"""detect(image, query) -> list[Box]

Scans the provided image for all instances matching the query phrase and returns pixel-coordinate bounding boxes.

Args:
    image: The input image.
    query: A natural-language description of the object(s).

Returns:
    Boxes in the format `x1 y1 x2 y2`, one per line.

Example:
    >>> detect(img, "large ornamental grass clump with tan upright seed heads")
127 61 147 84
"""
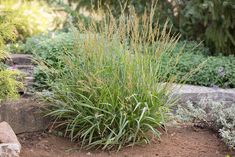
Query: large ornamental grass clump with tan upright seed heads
47 5 185 150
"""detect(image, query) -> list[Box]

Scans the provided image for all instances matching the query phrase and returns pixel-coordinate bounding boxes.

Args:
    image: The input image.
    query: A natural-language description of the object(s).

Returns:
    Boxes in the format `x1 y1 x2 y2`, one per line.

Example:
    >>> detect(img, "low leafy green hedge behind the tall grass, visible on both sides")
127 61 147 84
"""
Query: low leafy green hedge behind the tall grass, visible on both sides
26 33 235 88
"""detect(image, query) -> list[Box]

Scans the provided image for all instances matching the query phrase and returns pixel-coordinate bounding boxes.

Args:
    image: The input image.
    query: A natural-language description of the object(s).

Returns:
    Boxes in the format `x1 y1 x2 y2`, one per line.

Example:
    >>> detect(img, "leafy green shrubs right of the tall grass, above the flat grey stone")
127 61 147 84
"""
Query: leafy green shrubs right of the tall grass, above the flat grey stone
164 42 235 88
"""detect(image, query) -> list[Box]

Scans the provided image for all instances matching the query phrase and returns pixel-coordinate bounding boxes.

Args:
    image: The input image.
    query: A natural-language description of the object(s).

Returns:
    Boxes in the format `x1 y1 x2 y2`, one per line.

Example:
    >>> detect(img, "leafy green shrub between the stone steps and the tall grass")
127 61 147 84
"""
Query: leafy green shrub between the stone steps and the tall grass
24 32 74 89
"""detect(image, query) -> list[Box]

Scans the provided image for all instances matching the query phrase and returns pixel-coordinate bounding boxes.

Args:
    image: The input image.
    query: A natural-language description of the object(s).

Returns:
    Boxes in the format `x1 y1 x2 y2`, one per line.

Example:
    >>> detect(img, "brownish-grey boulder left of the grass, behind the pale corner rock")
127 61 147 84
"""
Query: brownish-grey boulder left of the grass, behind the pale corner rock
0 98 49 134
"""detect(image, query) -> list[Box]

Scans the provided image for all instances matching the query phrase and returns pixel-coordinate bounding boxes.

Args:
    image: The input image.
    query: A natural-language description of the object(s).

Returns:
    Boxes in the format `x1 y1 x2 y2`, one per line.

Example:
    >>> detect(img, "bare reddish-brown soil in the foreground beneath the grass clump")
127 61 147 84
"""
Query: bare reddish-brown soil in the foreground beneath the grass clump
18 126 235 157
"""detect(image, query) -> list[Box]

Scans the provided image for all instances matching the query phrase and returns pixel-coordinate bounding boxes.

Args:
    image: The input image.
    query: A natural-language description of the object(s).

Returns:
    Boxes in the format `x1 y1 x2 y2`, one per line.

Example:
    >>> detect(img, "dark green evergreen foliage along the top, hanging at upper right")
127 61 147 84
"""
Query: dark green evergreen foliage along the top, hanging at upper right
62 0 235 55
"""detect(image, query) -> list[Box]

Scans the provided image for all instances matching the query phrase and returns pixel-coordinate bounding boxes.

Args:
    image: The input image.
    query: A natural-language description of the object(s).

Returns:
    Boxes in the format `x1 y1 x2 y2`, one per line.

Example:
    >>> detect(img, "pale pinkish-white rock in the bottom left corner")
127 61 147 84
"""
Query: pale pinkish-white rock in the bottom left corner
0 122 21 157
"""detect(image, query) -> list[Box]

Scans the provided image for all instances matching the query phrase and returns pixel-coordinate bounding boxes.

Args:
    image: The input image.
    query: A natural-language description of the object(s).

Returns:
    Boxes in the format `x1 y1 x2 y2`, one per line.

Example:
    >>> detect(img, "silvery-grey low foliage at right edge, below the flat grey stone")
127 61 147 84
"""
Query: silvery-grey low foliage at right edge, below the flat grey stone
177 100 235 149
